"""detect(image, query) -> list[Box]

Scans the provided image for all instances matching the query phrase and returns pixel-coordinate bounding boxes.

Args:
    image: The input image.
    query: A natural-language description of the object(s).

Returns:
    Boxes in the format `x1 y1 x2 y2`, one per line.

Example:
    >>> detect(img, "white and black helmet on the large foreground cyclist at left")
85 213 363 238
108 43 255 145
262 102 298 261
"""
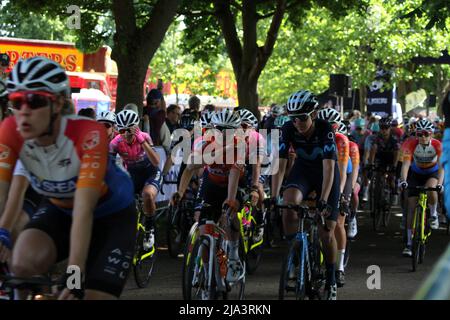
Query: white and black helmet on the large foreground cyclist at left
7 57 70 97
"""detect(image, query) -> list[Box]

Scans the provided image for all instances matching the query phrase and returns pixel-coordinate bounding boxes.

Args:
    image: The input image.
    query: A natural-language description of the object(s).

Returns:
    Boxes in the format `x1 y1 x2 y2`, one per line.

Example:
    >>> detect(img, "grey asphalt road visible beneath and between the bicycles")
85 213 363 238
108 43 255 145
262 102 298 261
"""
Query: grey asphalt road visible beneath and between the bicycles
121 207 450 300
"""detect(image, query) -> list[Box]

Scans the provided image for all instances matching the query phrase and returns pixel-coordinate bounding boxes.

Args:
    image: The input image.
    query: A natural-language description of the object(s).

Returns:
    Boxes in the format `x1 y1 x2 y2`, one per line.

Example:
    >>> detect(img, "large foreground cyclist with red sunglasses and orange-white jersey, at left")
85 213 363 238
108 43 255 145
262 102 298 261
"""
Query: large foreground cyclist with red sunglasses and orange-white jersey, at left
0 57 136 299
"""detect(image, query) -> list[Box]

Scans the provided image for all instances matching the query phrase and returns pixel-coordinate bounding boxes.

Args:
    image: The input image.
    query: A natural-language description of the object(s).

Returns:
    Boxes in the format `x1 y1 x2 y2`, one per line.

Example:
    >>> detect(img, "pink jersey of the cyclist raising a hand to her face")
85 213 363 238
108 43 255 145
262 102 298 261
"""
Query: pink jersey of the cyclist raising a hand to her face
109 132 153 166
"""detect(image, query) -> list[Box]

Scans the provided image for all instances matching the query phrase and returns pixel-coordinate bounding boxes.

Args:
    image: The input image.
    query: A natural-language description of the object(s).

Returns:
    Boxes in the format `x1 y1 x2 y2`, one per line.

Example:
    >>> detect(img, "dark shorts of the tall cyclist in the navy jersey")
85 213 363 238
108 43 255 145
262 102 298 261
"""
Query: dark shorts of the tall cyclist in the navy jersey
284 162 340 221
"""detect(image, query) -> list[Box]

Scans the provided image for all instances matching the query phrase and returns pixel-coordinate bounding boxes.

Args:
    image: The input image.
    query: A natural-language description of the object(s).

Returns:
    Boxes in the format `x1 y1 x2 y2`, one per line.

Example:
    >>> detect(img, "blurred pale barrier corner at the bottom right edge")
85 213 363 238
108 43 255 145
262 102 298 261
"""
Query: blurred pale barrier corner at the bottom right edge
413 244 450 300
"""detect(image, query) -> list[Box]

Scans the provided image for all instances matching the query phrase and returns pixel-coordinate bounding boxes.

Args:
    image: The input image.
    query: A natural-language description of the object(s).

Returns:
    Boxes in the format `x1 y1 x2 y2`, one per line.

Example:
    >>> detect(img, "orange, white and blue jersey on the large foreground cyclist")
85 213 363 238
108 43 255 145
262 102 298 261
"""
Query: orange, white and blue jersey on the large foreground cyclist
0 116 133 217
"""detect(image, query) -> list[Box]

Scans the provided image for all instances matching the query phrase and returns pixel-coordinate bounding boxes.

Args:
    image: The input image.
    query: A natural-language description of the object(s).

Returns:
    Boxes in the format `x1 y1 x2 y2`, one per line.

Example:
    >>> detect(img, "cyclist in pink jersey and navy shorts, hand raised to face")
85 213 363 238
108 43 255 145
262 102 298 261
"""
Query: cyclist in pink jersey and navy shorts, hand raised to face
109 110 162 250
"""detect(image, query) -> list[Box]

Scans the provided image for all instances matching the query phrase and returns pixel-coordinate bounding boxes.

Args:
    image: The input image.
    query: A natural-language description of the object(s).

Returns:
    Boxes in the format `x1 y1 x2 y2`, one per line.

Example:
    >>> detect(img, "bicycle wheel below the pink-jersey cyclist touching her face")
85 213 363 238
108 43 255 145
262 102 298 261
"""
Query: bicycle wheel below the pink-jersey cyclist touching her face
133 228 156 288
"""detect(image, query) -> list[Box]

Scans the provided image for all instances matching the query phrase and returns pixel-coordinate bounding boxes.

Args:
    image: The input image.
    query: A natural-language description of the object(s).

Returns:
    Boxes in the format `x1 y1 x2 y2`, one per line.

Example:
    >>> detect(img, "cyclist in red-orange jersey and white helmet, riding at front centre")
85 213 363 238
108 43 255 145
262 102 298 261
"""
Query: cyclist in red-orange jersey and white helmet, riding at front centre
172 109 245 282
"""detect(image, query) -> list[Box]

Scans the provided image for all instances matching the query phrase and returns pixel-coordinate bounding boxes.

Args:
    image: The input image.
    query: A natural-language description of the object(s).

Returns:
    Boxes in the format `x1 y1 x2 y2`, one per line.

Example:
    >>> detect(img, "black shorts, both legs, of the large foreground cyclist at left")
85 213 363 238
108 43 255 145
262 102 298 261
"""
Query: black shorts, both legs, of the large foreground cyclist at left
25 199 137 298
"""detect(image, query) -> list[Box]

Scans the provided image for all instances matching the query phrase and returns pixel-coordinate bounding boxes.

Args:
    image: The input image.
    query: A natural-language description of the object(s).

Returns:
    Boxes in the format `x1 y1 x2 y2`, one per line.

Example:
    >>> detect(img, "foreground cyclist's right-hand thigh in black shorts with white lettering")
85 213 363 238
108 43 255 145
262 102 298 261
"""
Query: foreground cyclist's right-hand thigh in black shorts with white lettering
85 203 137 300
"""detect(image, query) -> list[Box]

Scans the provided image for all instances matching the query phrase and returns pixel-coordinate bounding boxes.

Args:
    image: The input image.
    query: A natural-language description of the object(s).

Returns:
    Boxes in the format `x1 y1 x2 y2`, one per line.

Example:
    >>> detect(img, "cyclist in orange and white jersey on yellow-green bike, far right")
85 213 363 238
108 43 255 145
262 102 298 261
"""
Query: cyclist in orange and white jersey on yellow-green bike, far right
399 119 444 257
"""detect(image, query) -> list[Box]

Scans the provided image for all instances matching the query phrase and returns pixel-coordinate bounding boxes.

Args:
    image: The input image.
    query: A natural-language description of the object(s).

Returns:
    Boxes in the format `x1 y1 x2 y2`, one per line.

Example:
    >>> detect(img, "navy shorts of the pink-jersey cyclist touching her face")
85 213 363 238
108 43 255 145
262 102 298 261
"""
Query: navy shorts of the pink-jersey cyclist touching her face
128 159 162 193
